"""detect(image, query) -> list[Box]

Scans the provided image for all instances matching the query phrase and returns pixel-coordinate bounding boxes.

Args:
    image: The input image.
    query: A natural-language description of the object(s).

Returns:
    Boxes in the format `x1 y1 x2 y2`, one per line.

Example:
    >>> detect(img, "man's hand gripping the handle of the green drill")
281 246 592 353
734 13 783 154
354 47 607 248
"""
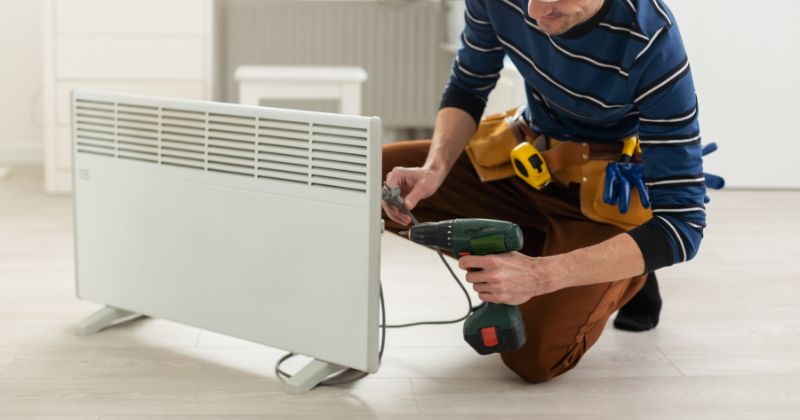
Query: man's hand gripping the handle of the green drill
458 252 567 305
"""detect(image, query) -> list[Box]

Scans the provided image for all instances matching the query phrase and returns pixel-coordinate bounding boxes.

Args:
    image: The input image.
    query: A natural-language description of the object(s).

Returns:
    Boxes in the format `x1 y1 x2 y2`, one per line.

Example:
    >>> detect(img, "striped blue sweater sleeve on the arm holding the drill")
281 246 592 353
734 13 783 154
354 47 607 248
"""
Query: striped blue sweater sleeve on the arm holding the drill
629 19 706 272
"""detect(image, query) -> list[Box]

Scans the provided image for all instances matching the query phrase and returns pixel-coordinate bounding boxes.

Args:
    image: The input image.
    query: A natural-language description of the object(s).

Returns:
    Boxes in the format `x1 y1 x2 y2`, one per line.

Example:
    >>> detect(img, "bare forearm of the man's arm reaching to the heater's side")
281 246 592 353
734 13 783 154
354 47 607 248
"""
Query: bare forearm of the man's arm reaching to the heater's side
423 108 477 176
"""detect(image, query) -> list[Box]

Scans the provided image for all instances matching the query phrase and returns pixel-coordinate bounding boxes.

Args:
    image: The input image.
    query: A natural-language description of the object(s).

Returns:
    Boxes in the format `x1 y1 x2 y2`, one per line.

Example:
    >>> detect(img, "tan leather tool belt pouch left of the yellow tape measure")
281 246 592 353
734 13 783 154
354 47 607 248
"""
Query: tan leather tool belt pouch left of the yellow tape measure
466 108 533 182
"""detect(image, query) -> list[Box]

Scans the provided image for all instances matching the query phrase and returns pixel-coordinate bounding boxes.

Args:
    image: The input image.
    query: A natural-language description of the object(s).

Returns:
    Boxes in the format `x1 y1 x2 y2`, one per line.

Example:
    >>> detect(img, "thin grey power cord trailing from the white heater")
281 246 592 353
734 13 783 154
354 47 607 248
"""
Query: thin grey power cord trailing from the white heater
275 185 486 386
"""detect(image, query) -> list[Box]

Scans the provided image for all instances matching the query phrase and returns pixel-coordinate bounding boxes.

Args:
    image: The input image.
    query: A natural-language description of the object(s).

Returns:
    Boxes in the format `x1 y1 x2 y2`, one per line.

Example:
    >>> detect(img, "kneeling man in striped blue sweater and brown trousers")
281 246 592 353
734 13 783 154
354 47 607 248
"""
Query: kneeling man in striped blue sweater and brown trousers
384 0 705 382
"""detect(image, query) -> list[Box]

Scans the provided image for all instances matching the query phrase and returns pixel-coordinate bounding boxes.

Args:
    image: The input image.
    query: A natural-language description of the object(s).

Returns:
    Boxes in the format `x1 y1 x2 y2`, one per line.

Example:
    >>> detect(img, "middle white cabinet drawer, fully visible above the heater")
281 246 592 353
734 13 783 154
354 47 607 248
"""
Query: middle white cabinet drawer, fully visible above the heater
55 37 206 80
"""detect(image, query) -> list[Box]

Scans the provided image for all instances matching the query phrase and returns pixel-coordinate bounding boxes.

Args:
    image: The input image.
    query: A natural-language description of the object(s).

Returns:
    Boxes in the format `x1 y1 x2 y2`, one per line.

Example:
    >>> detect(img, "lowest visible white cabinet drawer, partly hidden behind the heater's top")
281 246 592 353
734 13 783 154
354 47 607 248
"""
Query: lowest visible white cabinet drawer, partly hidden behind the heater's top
56 82 208 125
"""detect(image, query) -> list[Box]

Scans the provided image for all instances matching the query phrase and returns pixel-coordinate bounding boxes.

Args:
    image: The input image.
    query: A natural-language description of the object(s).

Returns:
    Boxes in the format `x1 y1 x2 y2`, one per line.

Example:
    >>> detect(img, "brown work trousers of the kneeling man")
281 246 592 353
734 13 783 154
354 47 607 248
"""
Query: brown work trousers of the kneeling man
382 140 645 382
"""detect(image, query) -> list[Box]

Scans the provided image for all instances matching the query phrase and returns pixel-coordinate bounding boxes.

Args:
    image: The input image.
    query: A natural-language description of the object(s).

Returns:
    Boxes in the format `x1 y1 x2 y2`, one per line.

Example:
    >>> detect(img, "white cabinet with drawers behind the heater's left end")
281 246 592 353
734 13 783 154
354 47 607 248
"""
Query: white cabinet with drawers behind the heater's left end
43 0 214 192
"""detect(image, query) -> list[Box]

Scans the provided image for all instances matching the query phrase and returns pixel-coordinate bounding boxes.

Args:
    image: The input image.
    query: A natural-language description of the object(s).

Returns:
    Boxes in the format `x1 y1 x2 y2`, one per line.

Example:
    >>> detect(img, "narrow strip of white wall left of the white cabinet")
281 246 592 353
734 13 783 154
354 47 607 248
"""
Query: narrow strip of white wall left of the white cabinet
0 0 42 162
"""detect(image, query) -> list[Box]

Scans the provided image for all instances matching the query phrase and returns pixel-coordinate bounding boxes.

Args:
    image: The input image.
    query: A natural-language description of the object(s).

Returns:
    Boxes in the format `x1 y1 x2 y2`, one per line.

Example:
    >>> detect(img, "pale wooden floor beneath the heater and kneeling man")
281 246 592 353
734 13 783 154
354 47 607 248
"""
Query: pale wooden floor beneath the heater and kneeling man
0 167 800 420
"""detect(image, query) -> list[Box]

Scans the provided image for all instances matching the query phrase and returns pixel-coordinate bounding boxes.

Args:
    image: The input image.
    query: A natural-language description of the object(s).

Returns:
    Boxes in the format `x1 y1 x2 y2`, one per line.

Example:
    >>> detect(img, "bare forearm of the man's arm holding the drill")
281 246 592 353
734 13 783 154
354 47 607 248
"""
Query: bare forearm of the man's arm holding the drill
542 233 644 289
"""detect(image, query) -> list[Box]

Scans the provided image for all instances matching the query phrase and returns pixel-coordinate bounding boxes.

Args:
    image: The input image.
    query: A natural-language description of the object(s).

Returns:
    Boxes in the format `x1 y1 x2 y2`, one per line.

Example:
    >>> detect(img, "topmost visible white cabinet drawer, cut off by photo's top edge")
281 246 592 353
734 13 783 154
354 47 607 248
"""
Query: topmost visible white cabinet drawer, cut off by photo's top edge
54 0 210 35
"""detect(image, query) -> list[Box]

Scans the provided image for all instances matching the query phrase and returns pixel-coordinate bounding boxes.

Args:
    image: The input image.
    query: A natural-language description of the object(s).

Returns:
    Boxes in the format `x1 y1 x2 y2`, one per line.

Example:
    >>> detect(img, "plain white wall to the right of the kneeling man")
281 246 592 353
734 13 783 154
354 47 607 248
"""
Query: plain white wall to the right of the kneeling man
665 0 800 188
